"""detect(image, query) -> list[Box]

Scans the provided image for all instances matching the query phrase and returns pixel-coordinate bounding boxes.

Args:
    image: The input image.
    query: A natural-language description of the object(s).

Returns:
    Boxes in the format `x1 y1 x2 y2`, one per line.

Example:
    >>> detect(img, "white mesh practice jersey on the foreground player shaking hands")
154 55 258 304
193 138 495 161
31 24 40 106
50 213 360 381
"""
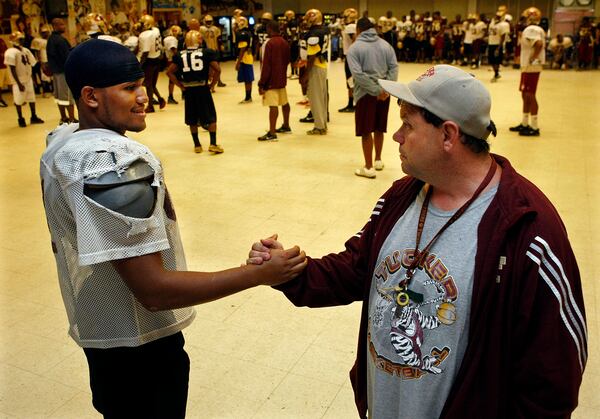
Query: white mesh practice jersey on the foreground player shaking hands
40 124 195 348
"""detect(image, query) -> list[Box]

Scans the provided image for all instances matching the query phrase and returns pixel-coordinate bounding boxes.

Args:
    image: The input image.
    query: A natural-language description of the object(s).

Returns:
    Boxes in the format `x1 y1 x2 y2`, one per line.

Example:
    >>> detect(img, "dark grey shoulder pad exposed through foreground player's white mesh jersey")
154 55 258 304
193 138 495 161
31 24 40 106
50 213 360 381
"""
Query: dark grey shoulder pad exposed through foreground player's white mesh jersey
84 161 156 218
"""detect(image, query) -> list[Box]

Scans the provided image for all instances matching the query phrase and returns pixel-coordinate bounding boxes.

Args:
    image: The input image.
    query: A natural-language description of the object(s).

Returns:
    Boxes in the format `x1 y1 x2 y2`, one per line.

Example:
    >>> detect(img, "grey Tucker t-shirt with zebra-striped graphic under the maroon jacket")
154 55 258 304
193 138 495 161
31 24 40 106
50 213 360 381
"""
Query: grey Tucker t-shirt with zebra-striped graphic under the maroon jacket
367 186 497 419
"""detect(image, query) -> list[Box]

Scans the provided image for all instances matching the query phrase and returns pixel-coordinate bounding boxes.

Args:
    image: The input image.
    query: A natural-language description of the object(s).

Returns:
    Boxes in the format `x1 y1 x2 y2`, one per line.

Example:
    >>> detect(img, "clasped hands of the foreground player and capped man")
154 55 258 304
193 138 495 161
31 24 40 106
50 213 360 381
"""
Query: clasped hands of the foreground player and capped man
246 234 307 286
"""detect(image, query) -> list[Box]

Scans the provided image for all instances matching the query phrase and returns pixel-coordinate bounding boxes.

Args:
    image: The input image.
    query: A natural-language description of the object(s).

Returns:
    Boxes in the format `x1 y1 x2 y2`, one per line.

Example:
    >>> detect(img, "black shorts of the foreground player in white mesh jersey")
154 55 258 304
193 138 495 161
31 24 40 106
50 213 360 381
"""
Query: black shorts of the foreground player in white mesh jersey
83 332 190 419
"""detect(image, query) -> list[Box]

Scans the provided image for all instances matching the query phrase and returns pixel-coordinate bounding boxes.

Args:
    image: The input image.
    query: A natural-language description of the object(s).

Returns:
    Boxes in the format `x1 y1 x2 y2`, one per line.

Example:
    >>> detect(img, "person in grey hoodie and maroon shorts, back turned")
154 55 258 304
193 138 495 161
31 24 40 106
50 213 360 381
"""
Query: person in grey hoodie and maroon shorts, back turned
346 17 398 179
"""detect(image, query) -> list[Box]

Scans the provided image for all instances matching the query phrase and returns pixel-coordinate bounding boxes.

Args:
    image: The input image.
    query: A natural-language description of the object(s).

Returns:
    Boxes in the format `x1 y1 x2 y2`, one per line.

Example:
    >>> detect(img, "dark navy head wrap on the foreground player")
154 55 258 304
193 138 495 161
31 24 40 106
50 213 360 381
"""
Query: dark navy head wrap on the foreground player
65 39 144 99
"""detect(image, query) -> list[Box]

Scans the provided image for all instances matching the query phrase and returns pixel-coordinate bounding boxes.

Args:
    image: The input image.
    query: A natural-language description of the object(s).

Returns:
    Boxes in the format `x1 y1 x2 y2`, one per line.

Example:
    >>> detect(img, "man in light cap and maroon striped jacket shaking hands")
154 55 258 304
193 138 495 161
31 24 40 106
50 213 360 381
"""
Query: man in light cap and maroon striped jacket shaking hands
248 65 587 419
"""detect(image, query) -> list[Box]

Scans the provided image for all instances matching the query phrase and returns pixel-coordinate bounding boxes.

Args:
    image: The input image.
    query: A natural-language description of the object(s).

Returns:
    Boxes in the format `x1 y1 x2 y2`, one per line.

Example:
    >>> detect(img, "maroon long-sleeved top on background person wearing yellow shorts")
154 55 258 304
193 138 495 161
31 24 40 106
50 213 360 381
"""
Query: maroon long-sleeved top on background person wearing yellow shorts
258 35 290 90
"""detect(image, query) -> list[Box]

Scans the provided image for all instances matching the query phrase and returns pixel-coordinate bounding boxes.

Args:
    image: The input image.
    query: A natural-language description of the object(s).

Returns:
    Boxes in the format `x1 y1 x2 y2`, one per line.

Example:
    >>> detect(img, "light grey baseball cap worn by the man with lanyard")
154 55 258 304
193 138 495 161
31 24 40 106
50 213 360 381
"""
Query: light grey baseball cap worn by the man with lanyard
379 64 496 140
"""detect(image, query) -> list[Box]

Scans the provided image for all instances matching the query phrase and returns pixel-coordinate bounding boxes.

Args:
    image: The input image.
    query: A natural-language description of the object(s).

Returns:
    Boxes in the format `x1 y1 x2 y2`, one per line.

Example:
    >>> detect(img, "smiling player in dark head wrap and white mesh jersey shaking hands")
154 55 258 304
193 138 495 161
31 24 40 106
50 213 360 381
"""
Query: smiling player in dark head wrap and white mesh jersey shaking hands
40 39 305 419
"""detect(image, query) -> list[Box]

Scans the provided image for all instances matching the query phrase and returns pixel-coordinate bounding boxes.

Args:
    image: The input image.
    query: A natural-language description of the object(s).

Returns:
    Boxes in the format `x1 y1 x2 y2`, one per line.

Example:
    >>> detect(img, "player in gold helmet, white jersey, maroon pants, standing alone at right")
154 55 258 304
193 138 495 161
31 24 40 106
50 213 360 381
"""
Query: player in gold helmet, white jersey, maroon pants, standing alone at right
510 7 546 137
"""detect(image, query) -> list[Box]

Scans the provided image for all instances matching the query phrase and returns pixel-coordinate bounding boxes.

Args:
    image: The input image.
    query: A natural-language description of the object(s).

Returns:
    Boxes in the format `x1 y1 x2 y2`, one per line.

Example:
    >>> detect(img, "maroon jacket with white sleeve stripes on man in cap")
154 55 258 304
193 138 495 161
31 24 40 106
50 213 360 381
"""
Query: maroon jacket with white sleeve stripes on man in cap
276 155 587 419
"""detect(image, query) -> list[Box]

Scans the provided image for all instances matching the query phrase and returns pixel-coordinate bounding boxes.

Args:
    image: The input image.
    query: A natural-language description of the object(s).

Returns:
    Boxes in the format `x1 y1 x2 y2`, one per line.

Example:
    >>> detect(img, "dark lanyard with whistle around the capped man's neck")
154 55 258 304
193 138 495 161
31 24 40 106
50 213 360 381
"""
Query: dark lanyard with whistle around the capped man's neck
395 158 498 306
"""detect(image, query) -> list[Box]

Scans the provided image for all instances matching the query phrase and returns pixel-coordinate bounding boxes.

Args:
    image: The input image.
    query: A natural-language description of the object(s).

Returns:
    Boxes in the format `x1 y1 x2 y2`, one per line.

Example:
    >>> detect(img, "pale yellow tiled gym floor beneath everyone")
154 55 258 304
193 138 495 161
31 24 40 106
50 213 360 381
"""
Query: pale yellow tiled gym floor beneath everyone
0 62 600 419
